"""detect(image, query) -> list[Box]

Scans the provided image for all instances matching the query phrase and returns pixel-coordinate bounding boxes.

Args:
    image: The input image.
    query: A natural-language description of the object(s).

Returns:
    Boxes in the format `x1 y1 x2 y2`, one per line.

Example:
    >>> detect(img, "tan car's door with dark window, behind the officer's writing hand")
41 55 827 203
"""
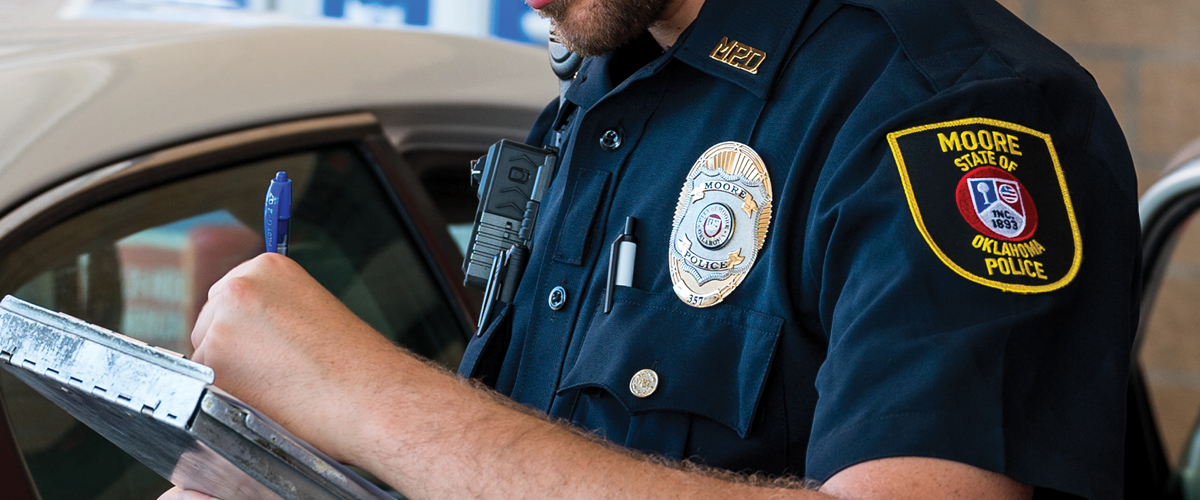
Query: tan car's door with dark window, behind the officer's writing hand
0 113 473 500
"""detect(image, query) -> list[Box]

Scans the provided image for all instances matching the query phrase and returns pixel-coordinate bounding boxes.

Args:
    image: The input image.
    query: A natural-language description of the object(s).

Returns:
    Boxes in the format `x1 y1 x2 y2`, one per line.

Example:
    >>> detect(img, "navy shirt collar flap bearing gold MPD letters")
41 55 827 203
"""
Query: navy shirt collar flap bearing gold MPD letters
674 0 814 98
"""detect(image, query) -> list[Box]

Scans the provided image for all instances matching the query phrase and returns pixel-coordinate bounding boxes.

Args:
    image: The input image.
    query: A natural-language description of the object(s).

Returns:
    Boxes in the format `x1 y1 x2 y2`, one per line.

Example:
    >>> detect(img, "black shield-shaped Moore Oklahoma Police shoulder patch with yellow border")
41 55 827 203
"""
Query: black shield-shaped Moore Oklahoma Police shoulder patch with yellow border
888 119 1084 294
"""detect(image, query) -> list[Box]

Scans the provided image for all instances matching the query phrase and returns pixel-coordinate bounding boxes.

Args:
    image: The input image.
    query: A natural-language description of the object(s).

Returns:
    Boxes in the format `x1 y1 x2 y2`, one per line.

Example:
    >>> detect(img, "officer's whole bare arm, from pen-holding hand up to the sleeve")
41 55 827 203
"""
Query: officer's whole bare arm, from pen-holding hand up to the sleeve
184 254 1028 500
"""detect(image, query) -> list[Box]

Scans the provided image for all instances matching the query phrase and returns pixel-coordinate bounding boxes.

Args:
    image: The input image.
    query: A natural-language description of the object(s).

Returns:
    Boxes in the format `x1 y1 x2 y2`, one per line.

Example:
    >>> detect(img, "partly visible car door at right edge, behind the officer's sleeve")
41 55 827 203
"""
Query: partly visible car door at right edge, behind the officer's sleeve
1126 149 1200 499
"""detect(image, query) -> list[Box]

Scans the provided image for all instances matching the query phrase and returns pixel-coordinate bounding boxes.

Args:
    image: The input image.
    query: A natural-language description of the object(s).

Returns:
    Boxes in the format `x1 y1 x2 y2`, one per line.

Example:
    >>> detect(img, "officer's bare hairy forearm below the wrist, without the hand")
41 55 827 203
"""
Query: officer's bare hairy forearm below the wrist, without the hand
347 351 829 499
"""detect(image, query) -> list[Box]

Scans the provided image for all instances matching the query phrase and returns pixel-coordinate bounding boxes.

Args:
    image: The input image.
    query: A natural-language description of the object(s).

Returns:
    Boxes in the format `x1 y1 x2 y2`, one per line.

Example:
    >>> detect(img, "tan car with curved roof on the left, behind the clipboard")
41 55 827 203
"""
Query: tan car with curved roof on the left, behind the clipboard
0 17 558 500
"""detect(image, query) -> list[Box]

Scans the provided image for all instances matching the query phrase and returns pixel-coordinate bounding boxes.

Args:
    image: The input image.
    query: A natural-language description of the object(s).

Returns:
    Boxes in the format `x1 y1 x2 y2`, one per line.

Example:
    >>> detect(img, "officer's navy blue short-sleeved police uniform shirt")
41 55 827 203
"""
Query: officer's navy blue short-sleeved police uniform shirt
461 0 1140 499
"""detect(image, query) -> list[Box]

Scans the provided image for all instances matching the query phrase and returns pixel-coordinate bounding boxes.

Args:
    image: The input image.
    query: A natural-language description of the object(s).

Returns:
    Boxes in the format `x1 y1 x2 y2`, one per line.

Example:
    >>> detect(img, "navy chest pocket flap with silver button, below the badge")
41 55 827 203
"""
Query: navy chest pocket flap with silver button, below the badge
559 287 784 438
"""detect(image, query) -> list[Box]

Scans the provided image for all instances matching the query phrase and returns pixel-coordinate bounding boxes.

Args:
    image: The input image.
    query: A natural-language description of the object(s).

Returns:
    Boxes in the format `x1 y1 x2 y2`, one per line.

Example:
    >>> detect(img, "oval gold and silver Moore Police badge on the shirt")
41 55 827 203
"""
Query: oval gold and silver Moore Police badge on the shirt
667 141 772 307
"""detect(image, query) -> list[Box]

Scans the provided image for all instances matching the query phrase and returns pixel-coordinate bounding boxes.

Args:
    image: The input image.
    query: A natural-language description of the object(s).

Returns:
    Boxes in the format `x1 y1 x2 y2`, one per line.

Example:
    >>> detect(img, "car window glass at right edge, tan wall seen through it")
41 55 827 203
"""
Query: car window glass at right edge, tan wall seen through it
1139 215 1200 464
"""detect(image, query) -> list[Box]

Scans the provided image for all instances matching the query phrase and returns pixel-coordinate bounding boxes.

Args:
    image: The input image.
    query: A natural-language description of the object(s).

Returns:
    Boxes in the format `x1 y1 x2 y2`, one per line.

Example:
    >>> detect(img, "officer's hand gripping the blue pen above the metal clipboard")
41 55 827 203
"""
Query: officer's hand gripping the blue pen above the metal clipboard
192 253 397 462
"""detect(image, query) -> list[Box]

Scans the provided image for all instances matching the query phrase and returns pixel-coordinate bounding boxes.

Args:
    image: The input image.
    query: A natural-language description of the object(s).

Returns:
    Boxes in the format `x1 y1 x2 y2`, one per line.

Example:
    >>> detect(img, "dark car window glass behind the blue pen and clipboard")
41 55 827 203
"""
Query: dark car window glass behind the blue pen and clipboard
0 146 466 500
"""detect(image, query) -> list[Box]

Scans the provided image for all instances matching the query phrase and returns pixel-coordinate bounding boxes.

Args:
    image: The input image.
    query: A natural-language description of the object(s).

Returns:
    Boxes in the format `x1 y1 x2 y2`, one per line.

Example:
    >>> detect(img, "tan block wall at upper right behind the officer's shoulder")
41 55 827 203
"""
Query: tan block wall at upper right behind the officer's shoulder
1000 0 1200 189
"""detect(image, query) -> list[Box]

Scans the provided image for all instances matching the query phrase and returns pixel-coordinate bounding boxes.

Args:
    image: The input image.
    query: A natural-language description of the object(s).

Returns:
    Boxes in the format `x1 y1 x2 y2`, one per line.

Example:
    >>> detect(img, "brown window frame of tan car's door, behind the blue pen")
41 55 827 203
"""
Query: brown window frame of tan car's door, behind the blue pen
0 112 478 500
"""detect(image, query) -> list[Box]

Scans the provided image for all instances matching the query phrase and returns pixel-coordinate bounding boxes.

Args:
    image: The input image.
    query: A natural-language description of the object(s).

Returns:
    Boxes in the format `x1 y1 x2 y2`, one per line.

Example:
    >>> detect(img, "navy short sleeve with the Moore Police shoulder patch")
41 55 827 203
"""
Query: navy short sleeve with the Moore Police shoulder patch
804 79 1140 499
